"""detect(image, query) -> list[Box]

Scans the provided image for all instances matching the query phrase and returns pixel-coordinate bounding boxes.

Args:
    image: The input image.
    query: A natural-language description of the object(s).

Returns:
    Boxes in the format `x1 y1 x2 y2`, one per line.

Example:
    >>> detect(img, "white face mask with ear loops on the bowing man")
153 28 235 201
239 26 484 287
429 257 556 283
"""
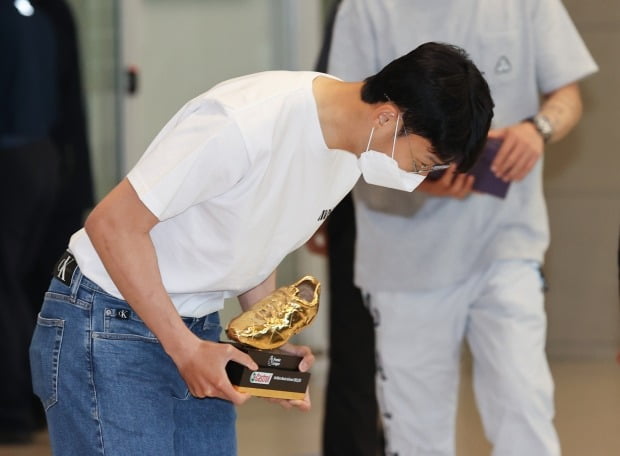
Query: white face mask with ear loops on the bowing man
357 115 426 192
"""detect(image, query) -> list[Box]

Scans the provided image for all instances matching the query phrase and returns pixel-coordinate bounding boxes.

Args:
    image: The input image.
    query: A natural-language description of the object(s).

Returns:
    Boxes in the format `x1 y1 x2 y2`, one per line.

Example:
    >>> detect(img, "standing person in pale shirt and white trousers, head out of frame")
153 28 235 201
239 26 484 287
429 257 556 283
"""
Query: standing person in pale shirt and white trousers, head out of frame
328 0 597 456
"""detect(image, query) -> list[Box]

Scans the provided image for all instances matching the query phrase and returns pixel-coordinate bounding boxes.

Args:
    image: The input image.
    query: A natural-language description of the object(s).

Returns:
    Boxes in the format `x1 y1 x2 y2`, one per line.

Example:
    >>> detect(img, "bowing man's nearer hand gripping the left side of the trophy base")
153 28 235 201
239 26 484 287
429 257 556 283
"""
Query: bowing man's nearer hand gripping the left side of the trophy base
173 338 258 405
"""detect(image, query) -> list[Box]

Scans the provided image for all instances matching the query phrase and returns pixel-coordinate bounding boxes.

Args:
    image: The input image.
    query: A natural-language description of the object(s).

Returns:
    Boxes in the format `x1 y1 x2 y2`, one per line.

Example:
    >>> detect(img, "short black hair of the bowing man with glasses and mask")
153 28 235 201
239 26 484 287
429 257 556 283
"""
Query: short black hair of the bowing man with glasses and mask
362 42 494 172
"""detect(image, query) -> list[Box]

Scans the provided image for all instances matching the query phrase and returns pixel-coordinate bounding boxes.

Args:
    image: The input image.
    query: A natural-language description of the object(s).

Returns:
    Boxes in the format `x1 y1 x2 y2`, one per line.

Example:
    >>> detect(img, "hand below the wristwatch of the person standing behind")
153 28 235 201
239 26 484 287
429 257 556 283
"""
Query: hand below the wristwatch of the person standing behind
489 122 545 182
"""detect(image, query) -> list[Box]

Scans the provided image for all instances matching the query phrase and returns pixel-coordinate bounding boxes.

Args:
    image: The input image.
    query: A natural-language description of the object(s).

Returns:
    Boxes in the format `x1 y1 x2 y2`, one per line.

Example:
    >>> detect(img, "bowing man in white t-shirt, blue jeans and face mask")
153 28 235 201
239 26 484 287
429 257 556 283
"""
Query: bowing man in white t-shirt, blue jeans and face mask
31 43 493 455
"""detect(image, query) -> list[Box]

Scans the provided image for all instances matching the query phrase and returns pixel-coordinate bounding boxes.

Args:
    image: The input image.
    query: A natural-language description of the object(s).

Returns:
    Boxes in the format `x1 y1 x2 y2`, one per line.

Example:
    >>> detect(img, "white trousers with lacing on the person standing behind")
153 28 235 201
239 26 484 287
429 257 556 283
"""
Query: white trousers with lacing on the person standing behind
366 260 560 456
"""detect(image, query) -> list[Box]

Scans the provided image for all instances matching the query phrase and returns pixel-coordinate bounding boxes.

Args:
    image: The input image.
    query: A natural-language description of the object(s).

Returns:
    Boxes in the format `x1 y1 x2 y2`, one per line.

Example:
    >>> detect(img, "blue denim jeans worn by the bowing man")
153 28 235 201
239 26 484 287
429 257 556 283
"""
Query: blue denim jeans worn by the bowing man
30 268 237 456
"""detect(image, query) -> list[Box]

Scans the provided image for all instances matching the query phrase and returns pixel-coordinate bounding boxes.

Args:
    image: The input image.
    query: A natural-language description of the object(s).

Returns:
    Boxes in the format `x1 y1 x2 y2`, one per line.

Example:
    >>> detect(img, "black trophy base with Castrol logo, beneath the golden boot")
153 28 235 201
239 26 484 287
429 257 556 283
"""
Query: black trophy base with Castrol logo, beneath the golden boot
226 343 310 399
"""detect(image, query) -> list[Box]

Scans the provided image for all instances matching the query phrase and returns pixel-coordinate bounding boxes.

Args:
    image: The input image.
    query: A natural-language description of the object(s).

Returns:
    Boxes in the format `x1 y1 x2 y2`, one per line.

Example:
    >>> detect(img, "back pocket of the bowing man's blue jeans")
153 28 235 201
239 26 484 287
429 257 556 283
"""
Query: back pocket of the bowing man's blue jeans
30 315 65 410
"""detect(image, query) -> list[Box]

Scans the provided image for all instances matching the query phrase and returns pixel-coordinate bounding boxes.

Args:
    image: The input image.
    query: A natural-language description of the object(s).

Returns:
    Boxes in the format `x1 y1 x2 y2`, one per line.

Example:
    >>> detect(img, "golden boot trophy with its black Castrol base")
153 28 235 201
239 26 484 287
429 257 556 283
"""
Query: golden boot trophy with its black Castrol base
226 276 321 399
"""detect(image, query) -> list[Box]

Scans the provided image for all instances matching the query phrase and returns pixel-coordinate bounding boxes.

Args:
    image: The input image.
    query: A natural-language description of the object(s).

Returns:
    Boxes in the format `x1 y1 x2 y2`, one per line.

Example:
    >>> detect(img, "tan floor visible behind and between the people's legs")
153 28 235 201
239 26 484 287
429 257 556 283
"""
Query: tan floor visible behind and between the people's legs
0 360 620 456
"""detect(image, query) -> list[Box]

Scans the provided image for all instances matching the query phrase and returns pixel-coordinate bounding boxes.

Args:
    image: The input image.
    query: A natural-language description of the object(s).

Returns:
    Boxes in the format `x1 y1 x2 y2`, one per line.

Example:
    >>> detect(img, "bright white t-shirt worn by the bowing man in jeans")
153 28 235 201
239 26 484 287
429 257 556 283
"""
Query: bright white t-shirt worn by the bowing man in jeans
69 71 360 317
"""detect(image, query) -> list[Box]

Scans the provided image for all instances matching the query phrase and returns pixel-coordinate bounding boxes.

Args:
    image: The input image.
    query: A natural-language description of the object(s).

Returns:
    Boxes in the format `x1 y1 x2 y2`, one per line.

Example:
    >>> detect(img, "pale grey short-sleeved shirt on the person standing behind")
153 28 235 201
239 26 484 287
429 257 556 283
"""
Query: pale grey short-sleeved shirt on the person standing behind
328 0 597 291
